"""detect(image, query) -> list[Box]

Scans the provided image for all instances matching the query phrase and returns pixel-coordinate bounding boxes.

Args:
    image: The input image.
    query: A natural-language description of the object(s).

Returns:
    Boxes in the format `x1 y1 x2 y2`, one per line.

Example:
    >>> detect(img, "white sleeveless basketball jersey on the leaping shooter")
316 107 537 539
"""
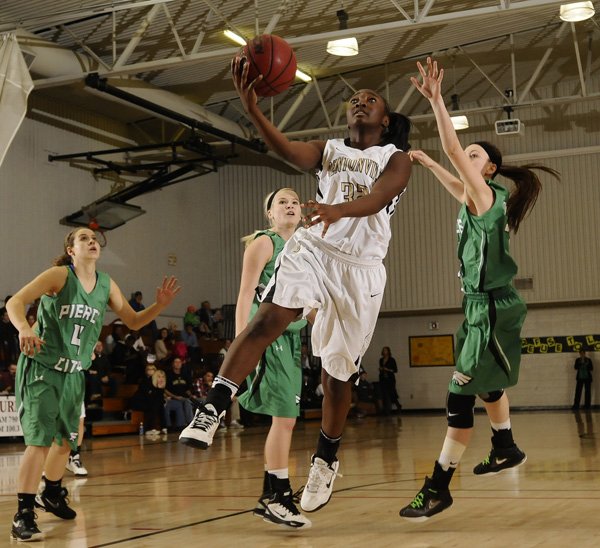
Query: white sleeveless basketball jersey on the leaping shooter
309 139 408 260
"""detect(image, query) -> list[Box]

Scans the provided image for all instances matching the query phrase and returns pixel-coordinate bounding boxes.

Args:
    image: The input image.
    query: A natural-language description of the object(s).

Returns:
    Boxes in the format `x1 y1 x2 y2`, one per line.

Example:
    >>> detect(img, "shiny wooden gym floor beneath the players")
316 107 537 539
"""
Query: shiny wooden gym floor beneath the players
0 411 600 548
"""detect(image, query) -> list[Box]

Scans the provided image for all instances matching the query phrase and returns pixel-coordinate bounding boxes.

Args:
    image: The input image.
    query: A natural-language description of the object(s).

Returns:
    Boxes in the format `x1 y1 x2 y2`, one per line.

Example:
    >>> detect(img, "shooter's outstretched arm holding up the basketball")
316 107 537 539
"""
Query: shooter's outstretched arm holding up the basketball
231 57 325 170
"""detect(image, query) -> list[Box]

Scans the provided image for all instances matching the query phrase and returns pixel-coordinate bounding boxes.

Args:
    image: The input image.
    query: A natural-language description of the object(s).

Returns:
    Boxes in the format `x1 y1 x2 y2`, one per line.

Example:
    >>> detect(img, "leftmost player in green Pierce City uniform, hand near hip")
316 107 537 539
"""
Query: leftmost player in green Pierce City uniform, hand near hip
6 228 180 541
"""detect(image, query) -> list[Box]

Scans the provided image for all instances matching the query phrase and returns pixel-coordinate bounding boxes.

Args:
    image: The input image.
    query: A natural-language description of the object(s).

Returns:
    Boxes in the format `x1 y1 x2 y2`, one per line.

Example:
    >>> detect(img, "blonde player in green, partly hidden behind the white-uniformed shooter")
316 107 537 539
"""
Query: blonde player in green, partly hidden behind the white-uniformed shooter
235 188 311 529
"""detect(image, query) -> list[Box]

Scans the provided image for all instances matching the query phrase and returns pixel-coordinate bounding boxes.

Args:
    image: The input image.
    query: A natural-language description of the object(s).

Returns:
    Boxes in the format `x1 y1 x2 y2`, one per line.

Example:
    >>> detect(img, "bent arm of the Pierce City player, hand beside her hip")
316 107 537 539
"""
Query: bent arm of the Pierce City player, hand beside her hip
6 266 67 356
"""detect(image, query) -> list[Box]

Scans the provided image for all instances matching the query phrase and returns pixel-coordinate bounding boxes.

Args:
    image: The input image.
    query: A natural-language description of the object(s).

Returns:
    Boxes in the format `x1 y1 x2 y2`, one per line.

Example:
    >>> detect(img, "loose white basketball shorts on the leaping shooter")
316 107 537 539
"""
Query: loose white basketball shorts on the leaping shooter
263 229 386 381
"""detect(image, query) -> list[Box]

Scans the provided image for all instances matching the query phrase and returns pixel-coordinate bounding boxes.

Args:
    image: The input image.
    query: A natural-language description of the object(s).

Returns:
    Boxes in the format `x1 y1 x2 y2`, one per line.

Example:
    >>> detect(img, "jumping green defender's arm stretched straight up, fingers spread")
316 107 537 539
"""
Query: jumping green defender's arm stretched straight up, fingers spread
410 57 494 215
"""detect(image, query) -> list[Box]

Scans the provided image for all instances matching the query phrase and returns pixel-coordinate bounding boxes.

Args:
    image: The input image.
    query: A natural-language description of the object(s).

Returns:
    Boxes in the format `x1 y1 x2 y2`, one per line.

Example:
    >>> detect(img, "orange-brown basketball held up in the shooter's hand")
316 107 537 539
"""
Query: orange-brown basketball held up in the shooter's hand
240 34 297 97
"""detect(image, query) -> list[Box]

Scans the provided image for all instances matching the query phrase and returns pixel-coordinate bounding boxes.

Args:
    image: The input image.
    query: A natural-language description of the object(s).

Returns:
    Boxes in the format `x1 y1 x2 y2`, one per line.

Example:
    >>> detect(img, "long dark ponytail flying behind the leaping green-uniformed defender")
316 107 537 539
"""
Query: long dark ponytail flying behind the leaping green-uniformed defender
498 164 560 234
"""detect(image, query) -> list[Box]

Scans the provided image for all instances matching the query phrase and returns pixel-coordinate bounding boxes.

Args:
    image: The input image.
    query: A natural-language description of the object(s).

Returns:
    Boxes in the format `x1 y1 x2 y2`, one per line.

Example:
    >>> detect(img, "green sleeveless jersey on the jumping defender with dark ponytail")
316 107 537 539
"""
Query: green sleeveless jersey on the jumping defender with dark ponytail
456 181 517 293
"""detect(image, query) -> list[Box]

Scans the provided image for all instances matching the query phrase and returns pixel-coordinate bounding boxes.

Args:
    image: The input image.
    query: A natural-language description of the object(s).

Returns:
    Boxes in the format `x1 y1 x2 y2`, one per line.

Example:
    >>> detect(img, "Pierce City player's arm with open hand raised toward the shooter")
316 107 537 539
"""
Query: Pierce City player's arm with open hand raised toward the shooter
108 276 181 331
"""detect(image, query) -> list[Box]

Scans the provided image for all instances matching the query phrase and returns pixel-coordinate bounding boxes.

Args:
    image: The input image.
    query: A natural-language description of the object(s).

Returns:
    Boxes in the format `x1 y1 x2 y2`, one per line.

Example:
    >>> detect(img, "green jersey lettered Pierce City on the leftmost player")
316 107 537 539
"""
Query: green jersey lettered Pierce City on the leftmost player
33 266 110 373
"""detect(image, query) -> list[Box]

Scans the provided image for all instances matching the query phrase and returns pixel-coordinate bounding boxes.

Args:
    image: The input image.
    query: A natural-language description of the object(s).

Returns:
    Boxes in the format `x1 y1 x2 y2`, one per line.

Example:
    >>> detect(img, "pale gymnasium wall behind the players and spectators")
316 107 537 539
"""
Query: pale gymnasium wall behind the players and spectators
0 79 600 408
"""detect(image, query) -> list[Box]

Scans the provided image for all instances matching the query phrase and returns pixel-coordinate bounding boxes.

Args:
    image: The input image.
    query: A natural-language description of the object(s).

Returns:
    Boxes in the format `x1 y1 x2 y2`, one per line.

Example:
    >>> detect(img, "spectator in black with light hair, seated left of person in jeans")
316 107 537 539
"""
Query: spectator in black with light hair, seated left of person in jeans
131 364 167 435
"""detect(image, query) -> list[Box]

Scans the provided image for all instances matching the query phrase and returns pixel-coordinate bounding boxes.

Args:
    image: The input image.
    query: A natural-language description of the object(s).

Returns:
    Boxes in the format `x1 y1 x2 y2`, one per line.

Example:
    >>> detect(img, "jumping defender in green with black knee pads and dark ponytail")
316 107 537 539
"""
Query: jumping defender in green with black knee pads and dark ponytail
400 58 557 521
